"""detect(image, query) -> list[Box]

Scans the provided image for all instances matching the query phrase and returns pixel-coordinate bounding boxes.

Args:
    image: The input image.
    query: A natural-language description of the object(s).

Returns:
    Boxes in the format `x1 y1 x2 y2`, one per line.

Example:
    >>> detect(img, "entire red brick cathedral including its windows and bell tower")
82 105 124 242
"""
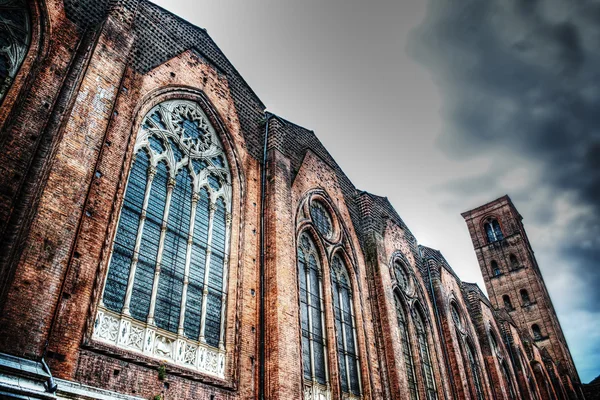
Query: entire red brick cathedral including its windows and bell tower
0 0 583 400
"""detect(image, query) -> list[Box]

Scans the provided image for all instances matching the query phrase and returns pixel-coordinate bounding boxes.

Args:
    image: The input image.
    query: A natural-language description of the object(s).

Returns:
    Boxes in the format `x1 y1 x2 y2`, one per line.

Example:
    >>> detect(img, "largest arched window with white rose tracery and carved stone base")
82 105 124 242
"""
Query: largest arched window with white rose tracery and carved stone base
94 99 231 378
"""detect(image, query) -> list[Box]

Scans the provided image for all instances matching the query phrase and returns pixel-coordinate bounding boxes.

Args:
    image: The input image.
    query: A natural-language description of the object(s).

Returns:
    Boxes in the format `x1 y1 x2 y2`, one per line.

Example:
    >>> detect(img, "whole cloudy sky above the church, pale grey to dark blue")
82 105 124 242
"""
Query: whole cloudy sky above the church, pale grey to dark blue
155 0 600 382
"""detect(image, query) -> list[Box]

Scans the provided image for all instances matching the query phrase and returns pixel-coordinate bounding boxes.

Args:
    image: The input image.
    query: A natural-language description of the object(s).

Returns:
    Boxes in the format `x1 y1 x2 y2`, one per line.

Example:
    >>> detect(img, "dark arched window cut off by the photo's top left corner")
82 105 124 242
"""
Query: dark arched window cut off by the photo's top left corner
0 0 31 102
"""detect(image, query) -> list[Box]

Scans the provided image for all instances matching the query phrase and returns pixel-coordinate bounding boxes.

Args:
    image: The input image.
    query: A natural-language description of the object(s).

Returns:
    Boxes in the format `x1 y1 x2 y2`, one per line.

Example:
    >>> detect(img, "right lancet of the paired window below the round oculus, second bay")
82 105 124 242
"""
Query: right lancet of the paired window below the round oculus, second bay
331 254 361 396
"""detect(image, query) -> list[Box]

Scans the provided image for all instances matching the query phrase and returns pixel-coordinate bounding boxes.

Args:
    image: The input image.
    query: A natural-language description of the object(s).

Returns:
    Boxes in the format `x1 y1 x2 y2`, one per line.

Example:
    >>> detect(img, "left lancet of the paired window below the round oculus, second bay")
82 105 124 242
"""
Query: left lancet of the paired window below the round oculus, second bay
298 233 329 386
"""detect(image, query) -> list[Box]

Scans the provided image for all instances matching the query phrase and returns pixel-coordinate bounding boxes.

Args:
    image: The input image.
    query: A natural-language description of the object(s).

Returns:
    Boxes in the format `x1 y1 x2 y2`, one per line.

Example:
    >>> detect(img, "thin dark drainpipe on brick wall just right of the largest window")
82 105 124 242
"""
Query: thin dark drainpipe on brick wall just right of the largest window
258 112 273 400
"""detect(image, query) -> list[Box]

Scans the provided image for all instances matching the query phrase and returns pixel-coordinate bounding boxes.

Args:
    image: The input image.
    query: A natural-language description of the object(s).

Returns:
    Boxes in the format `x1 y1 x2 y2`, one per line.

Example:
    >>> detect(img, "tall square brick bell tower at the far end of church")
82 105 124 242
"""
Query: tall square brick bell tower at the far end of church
462 195 580 392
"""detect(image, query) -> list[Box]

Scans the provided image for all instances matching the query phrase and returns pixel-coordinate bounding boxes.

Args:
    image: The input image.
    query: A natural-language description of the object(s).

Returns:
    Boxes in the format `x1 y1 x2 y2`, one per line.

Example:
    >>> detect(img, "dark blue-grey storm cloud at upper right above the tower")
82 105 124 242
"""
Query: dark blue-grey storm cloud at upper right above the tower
410 0 600 382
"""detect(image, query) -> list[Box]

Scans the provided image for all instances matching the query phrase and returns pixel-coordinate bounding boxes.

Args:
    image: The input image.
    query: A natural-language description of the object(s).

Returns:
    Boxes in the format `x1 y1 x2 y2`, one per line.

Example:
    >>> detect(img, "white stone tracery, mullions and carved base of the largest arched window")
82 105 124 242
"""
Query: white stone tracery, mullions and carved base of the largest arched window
92 98 232 378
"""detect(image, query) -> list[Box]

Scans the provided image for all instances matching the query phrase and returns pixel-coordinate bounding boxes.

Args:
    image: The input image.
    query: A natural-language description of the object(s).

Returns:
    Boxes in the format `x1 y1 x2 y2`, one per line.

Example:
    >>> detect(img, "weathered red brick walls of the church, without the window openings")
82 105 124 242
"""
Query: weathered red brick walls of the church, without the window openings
0 0 578 400
